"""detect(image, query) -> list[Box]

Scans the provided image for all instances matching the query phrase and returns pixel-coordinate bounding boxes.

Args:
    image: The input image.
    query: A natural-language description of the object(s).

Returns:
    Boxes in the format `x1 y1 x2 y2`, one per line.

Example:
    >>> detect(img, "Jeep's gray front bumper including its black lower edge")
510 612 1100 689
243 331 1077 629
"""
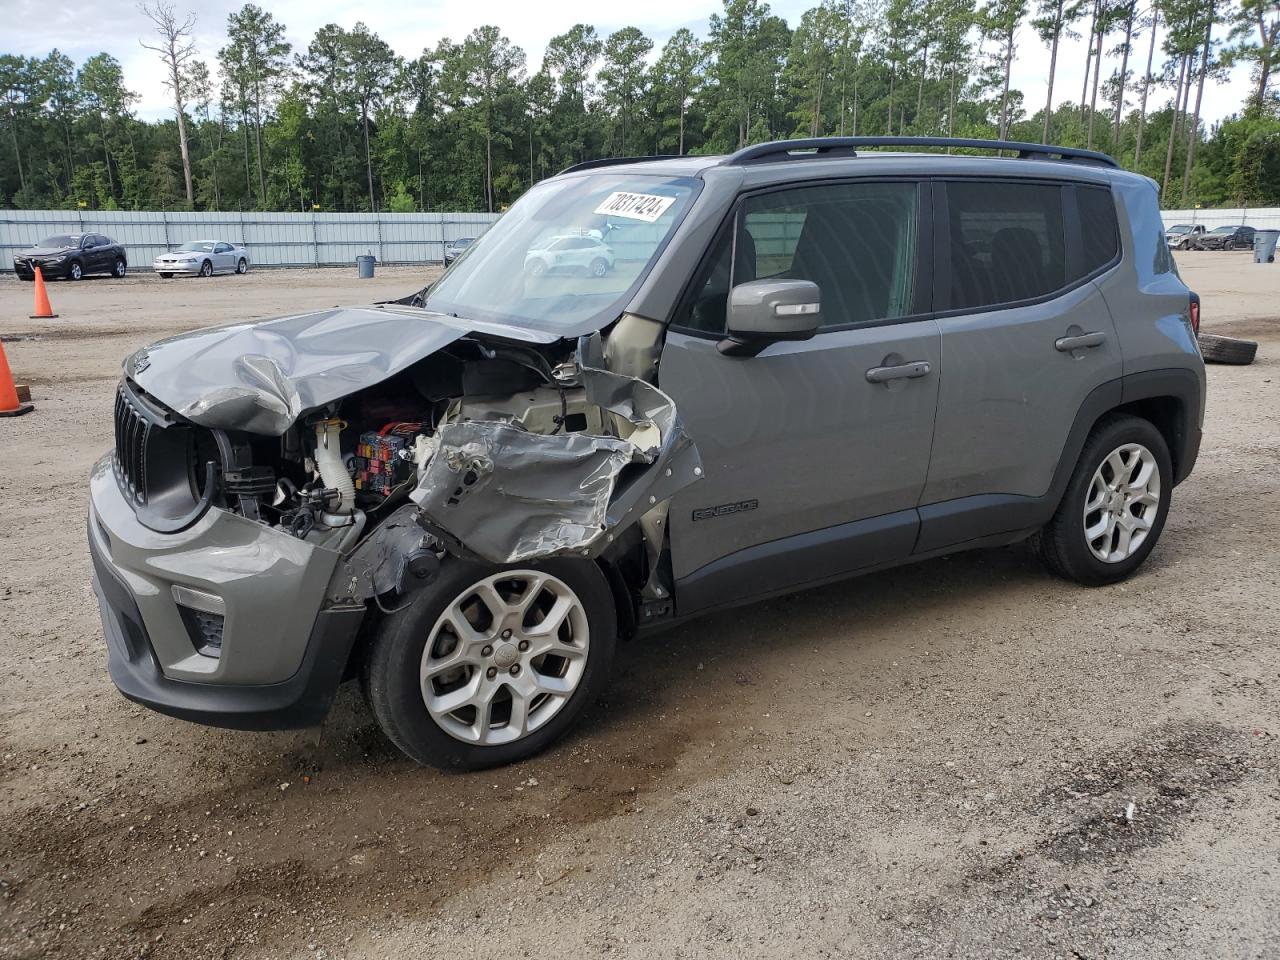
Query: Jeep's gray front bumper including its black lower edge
88 457 365 730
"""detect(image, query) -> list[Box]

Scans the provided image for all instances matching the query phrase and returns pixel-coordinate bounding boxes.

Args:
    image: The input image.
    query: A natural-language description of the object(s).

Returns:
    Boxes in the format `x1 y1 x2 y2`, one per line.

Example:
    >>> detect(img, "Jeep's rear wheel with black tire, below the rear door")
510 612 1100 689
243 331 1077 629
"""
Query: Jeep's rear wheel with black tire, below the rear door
1036 413 1174 586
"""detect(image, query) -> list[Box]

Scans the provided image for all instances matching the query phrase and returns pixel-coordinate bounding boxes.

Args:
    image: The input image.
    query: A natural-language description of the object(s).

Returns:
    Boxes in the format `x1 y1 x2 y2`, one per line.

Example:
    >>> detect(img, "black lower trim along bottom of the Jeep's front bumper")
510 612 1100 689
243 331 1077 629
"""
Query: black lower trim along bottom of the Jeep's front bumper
90 536 365 730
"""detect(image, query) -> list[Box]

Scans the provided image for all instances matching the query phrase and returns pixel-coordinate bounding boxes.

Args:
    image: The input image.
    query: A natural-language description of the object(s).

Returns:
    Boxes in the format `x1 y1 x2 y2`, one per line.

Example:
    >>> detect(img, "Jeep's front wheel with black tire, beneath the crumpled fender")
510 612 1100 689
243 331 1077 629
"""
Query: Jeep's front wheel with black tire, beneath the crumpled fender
364 559 617 771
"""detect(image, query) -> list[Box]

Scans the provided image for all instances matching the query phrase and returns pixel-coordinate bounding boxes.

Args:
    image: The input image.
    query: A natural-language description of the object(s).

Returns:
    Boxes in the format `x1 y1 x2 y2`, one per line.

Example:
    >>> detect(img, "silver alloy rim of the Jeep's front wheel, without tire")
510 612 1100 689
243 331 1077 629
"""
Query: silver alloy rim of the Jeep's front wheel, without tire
420 570 590 746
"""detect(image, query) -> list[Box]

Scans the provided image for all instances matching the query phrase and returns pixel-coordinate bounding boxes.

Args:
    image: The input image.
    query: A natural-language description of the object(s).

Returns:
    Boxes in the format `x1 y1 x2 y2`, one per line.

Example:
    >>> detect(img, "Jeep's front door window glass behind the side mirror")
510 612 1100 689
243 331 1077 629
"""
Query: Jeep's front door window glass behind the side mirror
684 183 919 333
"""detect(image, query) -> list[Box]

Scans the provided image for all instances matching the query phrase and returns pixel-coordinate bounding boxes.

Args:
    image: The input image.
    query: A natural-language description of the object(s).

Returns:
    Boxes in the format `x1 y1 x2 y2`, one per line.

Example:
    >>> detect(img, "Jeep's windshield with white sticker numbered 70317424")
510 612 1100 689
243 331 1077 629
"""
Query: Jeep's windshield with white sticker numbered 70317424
422 173 700 333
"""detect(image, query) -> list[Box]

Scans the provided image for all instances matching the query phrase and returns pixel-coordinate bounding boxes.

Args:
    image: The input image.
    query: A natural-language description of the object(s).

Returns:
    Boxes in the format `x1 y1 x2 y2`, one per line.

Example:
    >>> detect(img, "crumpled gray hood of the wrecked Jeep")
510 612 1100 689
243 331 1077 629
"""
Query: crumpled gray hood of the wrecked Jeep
124 305 557 436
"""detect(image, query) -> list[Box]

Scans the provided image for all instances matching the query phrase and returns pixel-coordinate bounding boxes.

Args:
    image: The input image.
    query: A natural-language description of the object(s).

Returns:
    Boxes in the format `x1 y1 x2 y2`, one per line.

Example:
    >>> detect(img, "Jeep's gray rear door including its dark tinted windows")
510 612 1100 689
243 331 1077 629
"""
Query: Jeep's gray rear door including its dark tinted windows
916 179 1121 553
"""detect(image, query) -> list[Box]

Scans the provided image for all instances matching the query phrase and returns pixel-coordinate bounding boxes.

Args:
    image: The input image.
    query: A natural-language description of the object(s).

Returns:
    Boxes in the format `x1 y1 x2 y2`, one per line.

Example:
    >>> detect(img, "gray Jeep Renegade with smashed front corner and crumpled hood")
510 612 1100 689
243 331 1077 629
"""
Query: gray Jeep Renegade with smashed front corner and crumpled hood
88 138 1204 768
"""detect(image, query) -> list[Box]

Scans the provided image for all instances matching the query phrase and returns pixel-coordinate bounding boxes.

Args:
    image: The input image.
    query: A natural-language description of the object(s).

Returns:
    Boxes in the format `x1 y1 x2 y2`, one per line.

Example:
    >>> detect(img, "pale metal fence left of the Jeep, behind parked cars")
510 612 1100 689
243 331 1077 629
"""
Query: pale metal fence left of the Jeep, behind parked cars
0 210 498 270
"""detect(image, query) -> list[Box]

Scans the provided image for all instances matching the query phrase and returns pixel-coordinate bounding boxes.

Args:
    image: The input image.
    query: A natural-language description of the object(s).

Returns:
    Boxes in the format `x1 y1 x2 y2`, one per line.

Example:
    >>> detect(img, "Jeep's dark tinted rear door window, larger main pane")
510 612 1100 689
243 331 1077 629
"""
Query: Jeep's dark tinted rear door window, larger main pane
947 182 1066 310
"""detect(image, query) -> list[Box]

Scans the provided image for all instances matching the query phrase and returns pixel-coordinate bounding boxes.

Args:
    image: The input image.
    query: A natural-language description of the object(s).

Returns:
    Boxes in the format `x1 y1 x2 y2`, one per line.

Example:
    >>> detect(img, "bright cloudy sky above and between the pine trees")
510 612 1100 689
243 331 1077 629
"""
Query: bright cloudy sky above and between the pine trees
0 0 1249 131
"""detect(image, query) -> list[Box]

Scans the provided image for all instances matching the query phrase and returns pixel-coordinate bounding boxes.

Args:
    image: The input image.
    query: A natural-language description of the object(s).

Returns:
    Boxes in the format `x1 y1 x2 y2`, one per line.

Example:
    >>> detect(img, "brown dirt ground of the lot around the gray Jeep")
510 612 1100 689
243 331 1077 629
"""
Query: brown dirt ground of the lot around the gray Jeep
0 253 1280 960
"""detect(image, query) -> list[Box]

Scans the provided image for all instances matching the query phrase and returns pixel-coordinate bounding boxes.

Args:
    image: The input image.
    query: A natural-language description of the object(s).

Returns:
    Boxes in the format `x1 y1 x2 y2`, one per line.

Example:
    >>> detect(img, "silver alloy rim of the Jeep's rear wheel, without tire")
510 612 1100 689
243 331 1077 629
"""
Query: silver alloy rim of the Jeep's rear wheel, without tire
1083 443 1160 563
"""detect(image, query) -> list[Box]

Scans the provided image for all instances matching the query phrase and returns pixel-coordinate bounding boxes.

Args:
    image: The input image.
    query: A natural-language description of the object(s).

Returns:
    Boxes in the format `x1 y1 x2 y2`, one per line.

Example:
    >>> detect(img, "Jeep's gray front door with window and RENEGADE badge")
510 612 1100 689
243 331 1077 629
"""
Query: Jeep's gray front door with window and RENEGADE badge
659 182 941 613
